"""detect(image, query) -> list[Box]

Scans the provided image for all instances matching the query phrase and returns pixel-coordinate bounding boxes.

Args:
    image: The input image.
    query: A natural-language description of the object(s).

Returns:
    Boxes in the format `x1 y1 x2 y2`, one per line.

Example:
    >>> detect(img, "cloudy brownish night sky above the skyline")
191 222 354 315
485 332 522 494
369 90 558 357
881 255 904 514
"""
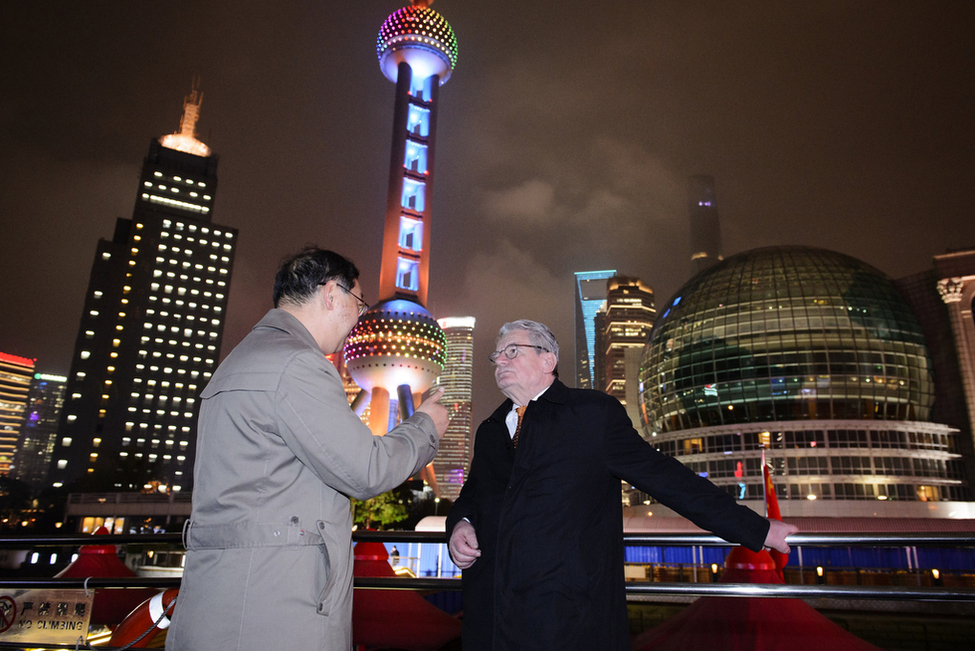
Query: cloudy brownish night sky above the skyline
0 0 975 421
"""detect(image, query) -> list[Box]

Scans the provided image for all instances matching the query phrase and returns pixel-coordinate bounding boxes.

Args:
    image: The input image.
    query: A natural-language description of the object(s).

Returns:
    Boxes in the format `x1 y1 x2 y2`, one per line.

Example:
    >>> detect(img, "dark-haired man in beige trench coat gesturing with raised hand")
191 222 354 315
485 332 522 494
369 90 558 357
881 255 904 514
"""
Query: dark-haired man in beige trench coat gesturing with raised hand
166 248 447 651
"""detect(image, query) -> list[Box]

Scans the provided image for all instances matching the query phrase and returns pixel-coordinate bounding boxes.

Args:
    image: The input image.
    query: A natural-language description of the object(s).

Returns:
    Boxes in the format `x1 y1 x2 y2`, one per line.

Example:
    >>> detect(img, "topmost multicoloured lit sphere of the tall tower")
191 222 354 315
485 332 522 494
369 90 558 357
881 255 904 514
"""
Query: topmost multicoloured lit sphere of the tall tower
376 2 457 85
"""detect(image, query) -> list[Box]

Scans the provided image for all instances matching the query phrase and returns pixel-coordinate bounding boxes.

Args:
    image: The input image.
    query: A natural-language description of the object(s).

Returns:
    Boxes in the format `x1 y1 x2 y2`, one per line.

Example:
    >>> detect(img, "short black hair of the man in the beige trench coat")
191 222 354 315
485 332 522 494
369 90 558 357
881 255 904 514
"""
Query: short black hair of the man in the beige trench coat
273 246 359 307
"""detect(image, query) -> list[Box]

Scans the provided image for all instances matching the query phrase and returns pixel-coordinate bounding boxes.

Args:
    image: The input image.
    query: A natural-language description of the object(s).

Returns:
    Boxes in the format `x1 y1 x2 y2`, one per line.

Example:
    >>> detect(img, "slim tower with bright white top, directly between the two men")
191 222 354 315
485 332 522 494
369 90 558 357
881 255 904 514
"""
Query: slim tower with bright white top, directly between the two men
433 316 474 500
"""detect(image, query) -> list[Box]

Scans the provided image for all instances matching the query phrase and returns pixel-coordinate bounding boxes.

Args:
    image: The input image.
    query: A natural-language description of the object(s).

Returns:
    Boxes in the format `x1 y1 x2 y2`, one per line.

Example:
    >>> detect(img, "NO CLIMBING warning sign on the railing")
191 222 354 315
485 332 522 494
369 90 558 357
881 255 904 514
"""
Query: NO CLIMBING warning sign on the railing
0 590 95 644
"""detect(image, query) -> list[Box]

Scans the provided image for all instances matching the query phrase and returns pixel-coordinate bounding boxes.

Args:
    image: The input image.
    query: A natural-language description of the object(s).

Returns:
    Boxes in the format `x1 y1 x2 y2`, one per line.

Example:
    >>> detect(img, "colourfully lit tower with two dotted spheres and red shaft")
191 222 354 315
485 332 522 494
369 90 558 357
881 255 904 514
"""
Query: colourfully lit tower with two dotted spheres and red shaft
345 0 457 446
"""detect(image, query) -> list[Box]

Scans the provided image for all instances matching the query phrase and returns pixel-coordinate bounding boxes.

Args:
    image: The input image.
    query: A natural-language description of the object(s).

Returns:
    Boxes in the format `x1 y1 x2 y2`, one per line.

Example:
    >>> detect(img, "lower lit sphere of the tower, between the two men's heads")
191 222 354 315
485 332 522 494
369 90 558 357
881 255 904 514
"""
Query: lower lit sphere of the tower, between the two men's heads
344 299 447 395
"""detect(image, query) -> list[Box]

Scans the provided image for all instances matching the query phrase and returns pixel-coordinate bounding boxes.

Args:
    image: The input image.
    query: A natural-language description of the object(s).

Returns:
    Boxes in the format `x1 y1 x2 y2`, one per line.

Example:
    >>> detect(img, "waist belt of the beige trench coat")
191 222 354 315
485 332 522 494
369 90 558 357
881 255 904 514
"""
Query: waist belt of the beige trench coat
183 516 325 550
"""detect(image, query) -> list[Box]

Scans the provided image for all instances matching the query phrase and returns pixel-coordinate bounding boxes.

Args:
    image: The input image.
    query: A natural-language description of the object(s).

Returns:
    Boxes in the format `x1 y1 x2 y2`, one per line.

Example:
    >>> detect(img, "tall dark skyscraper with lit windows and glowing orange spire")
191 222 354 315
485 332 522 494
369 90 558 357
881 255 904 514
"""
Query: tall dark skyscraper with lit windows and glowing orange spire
50 88 237 491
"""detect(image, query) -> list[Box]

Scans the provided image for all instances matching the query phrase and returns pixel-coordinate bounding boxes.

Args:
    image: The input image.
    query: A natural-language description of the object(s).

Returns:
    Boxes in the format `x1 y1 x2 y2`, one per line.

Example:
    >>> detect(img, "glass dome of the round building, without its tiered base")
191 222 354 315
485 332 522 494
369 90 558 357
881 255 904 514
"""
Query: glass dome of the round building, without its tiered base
640 246 934 434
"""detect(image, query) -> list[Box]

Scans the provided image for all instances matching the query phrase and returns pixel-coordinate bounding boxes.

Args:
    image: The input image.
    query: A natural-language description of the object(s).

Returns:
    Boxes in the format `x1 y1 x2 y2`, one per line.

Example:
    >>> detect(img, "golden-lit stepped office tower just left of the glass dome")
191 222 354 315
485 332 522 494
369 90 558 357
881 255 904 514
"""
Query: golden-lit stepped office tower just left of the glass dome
593 276 657 410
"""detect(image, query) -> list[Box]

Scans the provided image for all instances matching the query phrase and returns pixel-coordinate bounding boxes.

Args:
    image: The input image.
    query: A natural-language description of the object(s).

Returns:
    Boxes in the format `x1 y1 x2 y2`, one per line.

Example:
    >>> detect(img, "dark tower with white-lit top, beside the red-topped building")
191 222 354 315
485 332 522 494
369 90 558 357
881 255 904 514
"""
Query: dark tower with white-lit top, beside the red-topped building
10 373 68 494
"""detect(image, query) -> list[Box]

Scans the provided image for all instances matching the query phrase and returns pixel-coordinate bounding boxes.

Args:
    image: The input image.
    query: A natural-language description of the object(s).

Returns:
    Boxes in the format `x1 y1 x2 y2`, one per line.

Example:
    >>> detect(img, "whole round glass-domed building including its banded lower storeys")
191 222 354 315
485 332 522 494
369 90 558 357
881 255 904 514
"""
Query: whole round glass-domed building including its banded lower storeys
640 247 967 501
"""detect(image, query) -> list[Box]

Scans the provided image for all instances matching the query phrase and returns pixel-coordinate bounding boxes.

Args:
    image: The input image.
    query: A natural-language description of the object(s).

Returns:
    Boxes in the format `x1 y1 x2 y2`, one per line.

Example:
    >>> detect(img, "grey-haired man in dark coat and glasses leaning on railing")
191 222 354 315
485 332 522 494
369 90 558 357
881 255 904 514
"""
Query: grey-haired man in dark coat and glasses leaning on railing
447 320 796 651
